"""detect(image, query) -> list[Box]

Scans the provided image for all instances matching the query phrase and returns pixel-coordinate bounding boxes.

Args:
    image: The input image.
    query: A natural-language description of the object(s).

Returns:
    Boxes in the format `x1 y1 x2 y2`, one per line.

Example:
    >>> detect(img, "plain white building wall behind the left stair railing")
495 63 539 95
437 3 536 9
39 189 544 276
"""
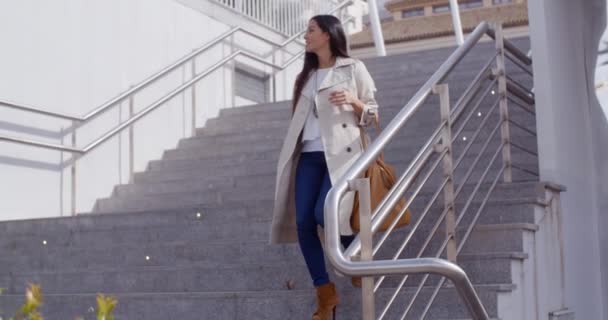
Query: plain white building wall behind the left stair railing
0 0 301 220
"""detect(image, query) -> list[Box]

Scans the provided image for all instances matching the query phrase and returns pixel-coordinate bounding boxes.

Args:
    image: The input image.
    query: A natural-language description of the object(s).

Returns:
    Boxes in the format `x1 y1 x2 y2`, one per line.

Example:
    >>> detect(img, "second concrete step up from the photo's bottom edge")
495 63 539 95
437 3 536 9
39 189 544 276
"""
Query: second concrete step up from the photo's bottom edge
0 224 526 276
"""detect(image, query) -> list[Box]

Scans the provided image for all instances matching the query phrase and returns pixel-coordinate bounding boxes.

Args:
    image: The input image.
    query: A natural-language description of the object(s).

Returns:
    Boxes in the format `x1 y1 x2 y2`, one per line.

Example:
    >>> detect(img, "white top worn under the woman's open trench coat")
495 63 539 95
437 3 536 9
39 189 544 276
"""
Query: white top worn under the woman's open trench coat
302 68 331 152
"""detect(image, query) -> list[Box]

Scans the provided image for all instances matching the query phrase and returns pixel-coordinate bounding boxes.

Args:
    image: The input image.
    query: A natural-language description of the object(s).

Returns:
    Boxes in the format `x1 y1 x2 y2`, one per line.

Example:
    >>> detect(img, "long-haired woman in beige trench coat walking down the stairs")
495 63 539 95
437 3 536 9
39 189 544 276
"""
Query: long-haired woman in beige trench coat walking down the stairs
270 15 378 320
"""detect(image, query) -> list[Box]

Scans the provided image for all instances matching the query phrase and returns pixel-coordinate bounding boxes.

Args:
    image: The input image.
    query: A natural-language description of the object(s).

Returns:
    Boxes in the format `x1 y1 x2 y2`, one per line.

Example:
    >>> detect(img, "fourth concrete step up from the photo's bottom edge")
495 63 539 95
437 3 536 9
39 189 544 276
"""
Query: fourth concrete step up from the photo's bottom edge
0 183 536 242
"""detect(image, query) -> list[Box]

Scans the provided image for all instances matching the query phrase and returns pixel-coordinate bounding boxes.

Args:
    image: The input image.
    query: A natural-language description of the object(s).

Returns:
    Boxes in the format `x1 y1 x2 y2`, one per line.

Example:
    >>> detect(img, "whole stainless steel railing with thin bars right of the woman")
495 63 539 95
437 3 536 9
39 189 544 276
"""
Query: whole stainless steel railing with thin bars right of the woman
325 22 538 320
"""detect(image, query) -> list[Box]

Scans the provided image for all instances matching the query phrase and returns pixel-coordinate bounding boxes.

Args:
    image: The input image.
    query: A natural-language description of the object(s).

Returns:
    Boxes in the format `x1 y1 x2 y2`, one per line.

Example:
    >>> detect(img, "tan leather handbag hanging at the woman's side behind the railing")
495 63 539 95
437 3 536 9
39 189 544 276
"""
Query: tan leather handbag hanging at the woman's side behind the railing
350 120 412 232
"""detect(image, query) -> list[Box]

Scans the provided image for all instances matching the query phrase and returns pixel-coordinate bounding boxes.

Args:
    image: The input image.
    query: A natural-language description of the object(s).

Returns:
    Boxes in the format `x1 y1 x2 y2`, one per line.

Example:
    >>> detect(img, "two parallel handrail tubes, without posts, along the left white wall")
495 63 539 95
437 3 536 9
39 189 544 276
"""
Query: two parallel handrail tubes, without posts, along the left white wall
0 0 353 154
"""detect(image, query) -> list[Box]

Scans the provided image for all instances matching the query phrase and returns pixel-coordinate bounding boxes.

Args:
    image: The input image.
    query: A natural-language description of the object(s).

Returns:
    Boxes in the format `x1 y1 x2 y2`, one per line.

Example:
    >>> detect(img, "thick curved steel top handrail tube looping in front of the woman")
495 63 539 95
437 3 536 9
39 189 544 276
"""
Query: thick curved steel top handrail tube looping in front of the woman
325 22 534 319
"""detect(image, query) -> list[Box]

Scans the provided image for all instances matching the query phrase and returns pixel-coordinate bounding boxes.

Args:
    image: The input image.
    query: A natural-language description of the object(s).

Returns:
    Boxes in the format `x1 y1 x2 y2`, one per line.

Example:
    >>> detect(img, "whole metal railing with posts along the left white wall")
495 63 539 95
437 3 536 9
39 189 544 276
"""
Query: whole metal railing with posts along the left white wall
0 0 352 214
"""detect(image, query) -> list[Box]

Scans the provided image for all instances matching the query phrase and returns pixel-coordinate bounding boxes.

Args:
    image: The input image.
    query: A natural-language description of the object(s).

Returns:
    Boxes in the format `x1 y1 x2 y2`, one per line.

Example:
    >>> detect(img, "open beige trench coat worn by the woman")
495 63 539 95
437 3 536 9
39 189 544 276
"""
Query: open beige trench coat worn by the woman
270 57 378 243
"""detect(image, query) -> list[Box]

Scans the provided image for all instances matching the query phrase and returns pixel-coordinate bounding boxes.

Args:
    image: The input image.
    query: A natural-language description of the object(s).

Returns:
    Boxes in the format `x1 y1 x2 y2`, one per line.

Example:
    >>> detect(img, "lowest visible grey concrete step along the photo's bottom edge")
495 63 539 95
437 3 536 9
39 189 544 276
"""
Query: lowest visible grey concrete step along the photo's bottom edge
0 281 514 320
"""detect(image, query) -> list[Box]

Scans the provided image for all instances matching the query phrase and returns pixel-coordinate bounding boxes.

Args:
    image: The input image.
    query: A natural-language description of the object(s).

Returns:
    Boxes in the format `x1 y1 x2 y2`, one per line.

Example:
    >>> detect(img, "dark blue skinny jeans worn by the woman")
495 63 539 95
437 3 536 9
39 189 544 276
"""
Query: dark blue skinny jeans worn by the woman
295 152 355 287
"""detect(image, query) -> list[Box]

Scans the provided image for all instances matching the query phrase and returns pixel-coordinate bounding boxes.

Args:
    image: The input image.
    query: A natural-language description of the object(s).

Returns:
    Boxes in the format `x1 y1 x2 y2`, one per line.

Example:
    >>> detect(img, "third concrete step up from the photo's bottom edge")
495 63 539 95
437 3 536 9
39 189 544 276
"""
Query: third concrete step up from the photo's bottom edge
0 195 534 268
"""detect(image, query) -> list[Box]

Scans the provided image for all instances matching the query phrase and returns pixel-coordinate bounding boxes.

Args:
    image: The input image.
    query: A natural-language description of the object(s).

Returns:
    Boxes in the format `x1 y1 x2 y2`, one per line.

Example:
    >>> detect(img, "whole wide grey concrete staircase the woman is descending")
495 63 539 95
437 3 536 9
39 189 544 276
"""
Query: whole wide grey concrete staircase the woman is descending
0 39 538 320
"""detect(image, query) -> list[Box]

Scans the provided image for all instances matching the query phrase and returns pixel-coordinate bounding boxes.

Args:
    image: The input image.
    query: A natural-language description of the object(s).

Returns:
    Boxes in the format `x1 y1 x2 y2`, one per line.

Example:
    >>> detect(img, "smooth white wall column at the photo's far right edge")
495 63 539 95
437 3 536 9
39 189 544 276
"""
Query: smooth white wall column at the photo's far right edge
528 0 608 319
